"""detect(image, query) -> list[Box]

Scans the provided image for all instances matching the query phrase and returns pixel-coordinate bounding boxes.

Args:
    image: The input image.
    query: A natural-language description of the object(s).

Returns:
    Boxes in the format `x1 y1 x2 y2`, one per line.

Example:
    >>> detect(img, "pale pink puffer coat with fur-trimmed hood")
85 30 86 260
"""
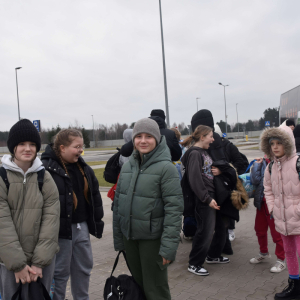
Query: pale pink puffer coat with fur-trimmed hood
261 126 300 235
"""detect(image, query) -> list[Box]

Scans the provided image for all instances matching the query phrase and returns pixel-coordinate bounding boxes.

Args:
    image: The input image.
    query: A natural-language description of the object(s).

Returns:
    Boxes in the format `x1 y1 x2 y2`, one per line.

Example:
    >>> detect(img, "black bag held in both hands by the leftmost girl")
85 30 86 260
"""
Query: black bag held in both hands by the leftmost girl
11 277 51 300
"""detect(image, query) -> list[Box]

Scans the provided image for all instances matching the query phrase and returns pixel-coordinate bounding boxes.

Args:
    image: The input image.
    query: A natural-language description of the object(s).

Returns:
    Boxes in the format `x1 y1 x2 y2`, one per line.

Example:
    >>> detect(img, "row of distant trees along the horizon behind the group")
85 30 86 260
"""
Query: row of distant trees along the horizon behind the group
0 107 279 148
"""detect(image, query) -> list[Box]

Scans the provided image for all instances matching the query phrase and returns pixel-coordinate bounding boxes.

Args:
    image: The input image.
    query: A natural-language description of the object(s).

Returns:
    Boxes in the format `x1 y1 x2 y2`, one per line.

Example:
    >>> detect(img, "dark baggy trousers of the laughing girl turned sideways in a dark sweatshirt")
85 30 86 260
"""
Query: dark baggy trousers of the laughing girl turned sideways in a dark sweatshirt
189 203 216 266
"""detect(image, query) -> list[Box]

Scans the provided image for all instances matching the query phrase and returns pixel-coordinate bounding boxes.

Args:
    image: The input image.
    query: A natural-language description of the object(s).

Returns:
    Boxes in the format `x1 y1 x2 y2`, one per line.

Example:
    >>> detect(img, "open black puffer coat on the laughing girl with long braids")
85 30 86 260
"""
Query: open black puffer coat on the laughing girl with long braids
42 144 104 240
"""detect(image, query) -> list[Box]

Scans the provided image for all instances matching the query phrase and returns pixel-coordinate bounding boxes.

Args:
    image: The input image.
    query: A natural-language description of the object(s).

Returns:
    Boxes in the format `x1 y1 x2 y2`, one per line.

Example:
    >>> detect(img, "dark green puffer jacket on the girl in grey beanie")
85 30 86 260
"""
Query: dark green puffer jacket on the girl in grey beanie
113 136 183 260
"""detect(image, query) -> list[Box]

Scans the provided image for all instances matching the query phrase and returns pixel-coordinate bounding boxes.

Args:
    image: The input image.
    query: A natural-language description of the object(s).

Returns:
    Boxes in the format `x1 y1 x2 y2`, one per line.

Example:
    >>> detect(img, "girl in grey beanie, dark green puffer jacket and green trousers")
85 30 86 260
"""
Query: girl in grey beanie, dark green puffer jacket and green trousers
113 118 183 300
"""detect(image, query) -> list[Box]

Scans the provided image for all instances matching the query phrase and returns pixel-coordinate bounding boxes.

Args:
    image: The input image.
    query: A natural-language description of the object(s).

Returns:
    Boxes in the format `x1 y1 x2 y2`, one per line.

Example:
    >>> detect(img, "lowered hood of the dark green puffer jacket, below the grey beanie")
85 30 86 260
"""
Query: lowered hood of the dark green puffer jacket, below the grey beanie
130 135 172 168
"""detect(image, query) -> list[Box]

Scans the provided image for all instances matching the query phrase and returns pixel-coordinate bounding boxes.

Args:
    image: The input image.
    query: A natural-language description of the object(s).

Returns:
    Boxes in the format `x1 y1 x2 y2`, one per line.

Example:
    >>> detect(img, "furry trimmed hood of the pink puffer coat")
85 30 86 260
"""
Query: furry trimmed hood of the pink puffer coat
260 124 296 159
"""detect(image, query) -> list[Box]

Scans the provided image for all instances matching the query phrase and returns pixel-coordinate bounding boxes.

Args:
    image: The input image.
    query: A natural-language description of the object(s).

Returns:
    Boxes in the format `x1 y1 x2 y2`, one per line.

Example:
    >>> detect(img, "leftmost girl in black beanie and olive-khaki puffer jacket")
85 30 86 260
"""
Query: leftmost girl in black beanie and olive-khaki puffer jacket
0 119 60 300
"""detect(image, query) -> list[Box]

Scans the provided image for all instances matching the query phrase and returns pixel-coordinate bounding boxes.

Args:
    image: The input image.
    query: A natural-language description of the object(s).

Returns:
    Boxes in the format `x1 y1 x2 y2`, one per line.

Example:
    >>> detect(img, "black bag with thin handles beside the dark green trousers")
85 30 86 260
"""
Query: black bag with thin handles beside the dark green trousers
103 251 146 300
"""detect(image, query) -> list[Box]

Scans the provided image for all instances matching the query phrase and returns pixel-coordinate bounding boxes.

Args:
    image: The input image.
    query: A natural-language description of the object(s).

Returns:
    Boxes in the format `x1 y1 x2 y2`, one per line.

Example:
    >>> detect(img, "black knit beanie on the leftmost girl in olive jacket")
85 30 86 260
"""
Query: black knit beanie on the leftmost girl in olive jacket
7 119 41 154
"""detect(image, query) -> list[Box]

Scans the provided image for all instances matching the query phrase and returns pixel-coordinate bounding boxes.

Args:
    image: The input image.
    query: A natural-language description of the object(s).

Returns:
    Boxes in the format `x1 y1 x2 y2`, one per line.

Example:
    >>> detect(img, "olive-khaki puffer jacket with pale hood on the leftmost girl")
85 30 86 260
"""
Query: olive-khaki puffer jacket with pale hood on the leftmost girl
0 155 60 273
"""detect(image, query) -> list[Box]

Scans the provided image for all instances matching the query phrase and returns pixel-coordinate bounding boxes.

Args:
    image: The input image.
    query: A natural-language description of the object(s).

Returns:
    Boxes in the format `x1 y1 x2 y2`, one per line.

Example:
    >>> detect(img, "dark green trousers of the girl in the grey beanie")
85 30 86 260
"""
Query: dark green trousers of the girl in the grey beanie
124 237 171 300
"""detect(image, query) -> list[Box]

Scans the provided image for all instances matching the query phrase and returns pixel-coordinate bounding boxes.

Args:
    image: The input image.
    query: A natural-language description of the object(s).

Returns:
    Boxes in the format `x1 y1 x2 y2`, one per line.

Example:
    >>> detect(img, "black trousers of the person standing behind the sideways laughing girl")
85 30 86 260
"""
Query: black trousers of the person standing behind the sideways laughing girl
208 211 229 258
